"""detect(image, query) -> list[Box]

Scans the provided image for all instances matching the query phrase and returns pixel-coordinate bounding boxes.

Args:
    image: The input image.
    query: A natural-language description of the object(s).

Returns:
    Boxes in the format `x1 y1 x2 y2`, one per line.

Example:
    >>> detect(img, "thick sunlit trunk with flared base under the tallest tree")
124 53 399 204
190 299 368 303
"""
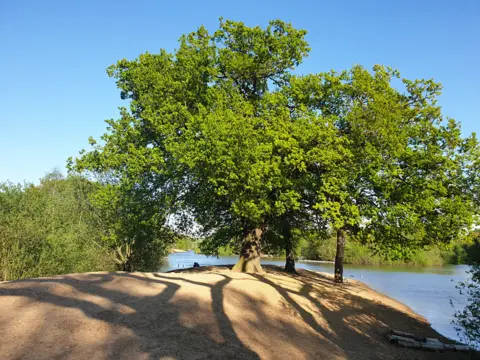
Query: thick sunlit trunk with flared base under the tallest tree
232 228 263 273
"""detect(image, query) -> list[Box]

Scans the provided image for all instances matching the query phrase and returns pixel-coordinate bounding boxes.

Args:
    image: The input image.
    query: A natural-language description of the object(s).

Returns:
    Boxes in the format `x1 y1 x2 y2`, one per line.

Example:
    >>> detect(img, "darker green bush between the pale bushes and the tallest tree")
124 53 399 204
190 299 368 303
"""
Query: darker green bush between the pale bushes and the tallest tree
87 182 175 271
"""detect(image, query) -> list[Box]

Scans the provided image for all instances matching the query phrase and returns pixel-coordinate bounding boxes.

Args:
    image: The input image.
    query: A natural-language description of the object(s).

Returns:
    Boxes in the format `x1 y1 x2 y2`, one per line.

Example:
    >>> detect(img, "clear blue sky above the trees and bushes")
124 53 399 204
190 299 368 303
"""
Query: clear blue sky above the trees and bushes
0 0 480 182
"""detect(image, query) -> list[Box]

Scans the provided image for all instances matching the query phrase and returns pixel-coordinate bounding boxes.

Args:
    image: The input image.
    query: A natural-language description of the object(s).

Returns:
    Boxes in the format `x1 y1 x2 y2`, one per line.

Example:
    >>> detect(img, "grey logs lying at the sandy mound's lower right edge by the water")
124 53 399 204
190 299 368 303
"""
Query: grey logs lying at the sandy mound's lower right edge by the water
387 330 472 352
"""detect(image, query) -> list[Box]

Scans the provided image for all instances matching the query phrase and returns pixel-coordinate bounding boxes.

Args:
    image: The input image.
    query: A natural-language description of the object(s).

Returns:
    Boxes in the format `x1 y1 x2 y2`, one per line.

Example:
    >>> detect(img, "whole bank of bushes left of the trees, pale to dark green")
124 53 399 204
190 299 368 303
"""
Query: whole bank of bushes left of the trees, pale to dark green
0 172 173 280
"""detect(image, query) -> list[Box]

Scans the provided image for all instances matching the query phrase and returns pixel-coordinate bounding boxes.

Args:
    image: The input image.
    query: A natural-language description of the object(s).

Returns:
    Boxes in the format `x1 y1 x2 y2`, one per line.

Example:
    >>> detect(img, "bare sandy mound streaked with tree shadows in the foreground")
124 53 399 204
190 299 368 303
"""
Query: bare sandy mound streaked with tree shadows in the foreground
0 267 469 360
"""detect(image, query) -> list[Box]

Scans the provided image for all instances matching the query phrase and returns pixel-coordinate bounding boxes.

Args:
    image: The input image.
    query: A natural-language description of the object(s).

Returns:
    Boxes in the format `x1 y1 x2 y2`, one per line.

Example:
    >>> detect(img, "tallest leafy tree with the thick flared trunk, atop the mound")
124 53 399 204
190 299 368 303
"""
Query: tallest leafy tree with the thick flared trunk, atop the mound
73 21 342 271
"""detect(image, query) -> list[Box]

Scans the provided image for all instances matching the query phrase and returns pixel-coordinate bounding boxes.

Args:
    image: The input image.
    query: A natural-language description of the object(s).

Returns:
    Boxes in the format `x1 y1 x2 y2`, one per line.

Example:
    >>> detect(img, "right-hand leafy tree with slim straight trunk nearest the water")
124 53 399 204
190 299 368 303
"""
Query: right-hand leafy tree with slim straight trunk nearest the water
286 66 477 282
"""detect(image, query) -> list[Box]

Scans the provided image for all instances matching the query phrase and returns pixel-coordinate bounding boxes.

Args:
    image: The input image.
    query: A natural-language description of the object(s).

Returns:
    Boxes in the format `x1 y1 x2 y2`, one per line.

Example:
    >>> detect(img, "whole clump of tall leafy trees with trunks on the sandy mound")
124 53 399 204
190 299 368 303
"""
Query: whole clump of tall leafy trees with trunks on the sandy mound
72 19 478 281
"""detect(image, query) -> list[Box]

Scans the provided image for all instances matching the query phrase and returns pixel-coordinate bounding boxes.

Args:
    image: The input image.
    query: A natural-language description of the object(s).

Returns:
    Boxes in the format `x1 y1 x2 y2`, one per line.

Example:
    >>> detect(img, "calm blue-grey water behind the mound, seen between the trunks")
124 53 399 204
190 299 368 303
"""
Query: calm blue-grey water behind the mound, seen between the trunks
159 252 468 340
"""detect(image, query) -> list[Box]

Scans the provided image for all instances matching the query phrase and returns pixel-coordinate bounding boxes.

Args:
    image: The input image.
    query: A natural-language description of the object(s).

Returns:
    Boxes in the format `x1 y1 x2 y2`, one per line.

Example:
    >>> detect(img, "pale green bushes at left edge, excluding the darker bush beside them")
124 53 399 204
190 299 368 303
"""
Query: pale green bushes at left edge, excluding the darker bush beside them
0 172 113 280
